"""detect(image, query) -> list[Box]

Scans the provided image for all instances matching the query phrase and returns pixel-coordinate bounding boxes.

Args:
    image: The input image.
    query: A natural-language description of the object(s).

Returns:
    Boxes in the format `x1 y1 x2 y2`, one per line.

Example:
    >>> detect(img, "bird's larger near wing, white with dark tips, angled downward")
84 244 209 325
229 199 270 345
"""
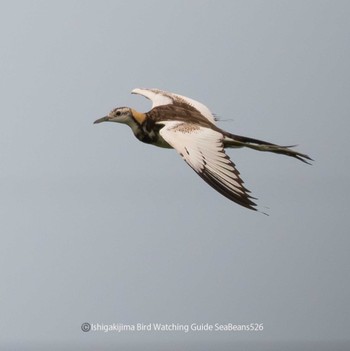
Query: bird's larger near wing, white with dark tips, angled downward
159 121 256 210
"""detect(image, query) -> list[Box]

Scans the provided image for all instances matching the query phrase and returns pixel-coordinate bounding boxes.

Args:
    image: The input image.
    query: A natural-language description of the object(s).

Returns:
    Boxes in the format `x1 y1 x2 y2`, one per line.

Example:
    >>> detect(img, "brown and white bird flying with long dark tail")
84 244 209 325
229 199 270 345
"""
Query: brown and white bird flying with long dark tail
94 89 312 211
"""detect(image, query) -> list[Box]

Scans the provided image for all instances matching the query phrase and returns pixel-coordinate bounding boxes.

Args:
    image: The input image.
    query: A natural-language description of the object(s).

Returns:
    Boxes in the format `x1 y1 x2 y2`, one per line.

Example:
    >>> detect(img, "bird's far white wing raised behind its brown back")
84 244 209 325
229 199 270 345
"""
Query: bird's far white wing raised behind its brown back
132 88 216 124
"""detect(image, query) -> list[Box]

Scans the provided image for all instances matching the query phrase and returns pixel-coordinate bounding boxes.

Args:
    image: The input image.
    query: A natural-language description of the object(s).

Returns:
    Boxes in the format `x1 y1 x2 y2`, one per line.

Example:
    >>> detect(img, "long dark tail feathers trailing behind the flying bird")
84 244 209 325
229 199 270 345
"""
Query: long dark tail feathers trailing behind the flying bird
224 132 313 164
